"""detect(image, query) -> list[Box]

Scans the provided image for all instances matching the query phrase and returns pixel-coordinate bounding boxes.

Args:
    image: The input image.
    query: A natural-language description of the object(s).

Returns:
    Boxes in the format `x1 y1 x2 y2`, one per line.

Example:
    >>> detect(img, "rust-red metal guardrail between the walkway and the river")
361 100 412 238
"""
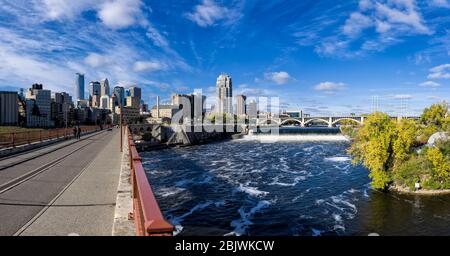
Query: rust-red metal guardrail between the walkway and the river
125 127 174 236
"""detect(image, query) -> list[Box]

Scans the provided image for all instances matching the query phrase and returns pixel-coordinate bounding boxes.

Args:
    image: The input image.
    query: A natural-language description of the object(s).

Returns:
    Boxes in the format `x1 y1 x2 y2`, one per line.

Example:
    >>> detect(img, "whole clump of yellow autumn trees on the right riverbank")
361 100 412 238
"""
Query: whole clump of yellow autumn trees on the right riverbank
349 103 450 191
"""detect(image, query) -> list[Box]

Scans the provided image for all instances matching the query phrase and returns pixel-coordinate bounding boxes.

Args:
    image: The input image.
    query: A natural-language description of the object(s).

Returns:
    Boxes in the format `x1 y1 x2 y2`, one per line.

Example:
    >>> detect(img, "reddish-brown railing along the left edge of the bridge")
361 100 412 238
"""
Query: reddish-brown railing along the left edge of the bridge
0 126 110 149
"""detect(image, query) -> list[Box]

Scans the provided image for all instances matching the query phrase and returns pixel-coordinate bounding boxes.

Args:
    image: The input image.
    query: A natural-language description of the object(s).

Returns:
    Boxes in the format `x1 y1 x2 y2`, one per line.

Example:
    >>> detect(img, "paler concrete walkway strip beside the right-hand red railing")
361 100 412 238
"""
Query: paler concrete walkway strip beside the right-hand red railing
16 130 122 236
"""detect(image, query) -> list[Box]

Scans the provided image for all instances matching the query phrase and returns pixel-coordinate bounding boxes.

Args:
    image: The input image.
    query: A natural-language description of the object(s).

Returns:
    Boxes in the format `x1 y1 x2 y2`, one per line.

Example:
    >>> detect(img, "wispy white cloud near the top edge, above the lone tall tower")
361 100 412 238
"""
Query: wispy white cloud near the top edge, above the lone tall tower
185 0 241 27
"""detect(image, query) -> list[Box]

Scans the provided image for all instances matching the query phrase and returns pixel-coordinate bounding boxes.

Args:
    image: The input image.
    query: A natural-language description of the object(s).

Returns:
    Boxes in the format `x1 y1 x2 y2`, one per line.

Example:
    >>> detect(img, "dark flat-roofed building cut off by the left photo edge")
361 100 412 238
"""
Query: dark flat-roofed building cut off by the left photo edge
0 92 19 126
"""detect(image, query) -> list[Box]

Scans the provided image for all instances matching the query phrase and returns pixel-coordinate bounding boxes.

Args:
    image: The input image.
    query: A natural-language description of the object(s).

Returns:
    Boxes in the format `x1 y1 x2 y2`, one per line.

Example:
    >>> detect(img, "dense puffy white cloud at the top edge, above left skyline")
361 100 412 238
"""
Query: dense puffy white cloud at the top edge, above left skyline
98 0 142 29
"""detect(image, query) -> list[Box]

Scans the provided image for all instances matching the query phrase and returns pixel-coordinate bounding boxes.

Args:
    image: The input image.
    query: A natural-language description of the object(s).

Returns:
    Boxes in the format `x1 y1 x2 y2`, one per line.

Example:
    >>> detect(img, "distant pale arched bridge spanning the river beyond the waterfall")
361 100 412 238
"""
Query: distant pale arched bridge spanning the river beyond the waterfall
257 116 365 127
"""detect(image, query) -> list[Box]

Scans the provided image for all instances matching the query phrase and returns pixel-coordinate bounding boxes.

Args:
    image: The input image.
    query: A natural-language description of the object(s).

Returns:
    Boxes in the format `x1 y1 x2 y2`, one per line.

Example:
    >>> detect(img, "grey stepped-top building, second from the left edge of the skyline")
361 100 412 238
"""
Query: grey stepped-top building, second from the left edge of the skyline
26 84 54 127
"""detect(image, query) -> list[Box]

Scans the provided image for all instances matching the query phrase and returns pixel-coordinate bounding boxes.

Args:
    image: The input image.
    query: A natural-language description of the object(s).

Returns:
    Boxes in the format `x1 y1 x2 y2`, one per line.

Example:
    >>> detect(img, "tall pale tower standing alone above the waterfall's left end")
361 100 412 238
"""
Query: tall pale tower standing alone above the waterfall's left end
216 74 233 114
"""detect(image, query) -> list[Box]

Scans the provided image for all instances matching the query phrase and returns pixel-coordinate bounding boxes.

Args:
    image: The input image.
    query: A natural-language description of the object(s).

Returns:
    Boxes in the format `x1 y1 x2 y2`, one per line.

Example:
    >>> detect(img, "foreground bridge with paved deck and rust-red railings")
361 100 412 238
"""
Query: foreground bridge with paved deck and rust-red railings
0 127 174 236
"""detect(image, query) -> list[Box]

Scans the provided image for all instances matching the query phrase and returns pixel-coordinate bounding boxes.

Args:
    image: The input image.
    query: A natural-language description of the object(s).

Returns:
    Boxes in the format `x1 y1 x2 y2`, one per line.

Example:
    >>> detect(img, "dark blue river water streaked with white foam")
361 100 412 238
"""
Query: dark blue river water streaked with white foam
141 135 450 236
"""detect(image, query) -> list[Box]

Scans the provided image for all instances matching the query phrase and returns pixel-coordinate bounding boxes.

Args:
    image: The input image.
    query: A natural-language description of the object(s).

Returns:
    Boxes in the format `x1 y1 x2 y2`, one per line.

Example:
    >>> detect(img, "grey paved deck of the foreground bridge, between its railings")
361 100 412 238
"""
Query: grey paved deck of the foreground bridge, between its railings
0 130 121 235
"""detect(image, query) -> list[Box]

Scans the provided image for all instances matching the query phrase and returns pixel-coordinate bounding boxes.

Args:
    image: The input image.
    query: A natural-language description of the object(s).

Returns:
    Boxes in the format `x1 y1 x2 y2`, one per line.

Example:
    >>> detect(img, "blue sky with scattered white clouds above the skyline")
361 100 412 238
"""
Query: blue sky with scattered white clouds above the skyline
0 0 450 115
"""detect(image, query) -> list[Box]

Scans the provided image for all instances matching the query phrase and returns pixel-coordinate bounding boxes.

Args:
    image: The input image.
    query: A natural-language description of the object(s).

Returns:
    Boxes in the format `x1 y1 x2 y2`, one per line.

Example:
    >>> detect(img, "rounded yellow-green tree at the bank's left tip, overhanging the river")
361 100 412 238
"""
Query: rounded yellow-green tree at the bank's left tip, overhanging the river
349 112 396 190
